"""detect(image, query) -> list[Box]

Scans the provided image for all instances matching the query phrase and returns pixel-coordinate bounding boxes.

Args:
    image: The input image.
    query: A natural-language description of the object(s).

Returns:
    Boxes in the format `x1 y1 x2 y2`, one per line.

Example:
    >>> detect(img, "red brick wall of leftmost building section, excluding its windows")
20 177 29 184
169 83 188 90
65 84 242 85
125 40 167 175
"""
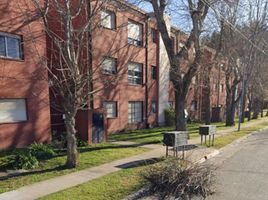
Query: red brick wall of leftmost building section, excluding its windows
0 0 51 149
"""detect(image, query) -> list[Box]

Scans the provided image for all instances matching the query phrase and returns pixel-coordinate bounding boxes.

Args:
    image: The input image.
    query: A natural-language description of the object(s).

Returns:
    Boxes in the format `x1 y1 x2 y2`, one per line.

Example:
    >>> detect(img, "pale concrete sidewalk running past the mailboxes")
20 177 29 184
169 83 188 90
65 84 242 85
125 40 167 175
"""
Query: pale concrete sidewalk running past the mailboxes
0 118 267 200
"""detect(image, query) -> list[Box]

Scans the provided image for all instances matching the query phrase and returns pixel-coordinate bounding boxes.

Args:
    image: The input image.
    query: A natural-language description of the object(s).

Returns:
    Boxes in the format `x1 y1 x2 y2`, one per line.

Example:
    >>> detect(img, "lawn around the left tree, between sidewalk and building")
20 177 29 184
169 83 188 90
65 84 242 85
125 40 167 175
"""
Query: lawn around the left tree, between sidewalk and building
0 144 147 193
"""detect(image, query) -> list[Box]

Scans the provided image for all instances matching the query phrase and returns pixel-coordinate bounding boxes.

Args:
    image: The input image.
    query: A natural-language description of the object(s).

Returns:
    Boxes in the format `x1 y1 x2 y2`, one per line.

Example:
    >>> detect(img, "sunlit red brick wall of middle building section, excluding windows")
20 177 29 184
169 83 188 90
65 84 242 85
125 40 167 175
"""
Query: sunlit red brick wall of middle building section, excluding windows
93 10 158 132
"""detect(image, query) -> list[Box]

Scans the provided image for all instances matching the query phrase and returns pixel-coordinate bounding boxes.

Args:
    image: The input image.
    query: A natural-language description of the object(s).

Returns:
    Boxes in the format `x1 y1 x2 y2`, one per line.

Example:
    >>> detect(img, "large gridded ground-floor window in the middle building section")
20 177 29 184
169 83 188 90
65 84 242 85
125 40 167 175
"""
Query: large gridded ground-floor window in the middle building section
128 101 143 123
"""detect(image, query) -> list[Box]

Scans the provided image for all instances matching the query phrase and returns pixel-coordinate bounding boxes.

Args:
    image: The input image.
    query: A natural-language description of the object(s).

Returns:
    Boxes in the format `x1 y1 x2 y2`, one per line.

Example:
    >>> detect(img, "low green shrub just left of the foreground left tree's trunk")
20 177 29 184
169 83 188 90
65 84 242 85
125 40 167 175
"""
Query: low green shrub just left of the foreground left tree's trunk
29 143 56 160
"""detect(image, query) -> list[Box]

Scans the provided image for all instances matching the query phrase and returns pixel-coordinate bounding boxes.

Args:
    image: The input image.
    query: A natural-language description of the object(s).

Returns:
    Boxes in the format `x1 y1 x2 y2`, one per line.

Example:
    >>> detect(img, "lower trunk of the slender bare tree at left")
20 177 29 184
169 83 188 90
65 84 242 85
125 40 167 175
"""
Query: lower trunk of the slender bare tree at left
65 115 78 168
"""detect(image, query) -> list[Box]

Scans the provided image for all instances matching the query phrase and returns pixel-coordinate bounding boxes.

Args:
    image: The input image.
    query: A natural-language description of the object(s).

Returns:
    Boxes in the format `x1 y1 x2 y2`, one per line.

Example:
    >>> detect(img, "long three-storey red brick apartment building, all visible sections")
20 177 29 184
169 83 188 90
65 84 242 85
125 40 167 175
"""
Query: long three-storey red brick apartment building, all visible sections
0 0 225 149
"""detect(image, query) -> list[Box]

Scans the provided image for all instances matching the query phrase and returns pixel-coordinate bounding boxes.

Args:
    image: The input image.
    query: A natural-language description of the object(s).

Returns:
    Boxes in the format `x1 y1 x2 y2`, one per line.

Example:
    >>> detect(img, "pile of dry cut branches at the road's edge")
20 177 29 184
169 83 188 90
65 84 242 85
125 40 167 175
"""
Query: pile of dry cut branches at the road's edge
143 158 214 200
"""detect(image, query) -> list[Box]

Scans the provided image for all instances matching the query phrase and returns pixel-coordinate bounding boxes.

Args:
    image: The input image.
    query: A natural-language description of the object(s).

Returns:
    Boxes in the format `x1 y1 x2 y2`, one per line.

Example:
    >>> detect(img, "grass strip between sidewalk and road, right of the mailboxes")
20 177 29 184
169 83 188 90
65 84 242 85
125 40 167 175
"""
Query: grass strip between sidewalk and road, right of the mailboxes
206 122 268 149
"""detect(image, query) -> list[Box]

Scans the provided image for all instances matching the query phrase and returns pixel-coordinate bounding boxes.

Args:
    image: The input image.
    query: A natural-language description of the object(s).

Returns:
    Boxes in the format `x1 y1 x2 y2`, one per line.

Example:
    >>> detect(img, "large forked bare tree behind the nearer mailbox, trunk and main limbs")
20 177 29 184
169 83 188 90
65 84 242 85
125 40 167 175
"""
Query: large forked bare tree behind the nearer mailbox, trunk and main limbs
149 0 209 131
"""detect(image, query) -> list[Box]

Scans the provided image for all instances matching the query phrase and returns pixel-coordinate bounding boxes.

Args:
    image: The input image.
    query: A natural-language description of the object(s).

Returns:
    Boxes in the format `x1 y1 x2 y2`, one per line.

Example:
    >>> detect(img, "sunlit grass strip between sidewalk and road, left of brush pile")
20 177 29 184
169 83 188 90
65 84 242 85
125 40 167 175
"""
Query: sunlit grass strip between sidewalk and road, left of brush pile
41 167 145 200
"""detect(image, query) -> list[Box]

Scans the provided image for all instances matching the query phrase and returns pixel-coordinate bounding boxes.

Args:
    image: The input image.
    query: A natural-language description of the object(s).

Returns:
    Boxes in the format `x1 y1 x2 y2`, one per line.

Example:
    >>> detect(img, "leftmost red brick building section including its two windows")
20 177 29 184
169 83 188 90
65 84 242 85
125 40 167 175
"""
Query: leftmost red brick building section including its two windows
0 0 51 149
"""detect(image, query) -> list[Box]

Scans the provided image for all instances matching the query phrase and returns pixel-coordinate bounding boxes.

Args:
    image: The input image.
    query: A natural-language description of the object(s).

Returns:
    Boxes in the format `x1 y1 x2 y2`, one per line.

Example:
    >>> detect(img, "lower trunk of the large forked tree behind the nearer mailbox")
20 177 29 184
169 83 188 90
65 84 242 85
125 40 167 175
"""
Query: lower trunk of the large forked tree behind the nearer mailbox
175 90 187 131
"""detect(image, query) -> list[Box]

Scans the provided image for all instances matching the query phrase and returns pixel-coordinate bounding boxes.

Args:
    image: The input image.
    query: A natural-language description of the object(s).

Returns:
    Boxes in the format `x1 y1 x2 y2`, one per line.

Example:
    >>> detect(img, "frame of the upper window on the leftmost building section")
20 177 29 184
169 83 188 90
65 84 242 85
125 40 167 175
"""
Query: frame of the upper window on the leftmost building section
0 32 23 60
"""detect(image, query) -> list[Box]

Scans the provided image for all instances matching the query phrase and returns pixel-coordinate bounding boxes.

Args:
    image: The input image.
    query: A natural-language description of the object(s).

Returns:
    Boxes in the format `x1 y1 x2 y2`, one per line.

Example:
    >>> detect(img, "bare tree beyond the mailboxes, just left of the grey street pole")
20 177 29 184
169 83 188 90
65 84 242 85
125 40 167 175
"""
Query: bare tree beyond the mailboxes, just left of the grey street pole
205 0 245 126
